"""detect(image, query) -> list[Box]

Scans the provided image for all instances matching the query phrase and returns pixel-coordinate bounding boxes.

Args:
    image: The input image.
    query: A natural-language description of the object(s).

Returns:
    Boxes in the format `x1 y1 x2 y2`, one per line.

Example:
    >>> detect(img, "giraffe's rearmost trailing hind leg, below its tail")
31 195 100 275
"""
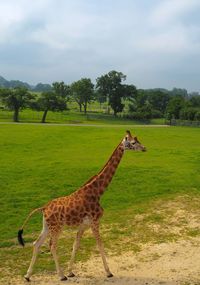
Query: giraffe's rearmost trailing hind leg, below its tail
24 217 49 281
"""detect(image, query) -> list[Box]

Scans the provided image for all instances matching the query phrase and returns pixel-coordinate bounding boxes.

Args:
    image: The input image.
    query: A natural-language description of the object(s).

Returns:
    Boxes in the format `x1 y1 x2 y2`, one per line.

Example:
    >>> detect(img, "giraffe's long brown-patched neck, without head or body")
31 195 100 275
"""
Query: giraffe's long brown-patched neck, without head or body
80 142 124 196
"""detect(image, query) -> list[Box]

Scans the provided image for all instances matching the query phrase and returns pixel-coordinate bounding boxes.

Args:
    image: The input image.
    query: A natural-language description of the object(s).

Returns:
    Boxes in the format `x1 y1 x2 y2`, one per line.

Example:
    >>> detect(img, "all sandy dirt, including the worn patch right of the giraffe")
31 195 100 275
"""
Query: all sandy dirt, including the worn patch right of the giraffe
0 197 200 285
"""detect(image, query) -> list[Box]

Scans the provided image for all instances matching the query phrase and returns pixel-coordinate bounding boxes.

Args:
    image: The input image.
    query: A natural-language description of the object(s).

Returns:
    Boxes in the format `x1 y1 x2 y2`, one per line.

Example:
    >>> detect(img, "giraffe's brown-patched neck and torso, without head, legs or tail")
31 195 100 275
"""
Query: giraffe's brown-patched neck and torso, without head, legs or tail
43 142 124 236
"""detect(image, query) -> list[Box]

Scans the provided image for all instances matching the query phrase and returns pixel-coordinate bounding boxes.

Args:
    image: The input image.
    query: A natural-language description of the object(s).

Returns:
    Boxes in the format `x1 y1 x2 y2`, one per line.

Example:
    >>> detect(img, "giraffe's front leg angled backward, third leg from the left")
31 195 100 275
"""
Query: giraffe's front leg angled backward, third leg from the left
68 224 88 277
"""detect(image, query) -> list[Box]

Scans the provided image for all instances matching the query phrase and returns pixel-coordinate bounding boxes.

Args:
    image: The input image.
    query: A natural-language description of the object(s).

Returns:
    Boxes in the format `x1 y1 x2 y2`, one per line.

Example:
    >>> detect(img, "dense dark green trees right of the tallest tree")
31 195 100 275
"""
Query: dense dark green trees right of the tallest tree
126 88 200 122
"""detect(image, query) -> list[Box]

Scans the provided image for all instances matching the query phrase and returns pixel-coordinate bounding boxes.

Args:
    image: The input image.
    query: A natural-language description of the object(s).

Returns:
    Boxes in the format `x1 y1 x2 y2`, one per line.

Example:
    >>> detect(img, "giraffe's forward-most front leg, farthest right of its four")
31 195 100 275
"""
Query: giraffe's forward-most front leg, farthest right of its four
91 222 113 277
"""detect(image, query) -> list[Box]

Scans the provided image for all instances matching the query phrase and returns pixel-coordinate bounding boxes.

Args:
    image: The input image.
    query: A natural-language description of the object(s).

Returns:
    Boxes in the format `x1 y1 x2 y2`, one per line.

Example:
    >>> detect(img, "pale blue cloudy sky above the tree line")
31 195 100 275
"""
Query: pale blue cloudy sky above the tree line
0 0 200 92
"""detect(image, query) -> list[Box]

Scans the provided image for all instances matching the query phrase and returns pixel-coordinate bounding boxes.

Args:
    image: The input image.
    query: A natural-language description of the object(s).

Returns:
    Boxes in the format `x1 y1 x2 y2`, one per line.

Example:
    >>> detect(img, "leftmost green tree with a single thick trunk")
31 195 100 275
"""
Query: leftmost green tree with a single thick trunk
0 87 34 122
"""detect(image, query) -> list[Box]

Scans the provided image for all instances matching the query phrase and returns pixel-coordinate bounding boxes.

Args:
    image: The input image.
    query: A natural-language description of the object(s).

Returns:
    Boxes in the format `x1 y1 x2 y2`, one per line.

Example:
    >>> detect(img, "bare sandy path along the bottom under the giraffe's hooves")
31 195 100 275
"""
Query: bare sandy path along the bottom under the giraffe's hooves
4 238 200 285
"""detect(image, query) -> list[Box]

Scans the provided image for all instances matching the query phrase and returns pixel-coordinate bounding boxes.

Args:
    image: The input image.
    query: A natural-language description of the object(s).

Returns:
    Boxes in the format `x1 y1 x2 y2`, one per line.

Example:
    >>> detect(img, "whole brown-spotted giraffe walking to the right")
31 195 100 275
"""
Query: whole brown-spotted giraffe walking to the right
18 131 146 281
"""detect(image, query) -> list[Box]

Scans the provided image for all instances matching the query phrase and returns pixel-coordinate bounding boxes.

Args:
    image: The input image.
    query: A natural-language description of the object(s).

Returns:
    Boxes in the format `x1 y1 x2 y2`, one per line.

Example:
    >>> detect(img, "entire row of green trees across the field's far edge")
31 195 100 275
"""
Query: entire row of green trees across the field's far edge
0 70 200 123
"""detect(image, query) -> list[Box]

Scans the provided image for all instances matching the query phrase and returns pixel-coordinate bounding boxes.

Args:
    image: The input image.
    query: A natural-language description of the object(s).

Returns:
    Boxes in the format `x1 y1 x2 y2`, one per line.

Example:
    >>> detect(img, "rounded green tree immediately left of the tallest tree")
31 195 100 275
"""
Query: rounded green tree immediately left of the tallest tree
70 78 94 114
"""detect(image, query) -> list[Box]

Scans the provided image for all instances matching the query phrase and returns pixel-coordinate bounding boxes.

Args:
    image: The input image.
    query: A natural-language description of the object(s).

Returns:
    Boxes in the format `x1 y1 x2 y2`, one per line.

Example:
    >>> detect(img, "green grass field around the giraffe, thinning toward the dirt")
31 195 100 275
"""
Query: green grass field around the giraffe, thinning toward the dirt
0 124 200 276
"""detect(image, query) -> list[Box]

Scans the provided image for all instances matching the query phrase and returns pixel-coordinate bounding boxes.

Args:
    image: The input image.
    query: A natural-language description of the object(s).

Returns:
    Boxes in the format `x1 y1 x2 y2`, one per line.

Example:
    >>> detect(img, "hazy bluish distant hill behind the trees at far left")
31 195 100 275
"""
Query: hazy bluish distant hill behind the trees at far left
0 76 52 92
